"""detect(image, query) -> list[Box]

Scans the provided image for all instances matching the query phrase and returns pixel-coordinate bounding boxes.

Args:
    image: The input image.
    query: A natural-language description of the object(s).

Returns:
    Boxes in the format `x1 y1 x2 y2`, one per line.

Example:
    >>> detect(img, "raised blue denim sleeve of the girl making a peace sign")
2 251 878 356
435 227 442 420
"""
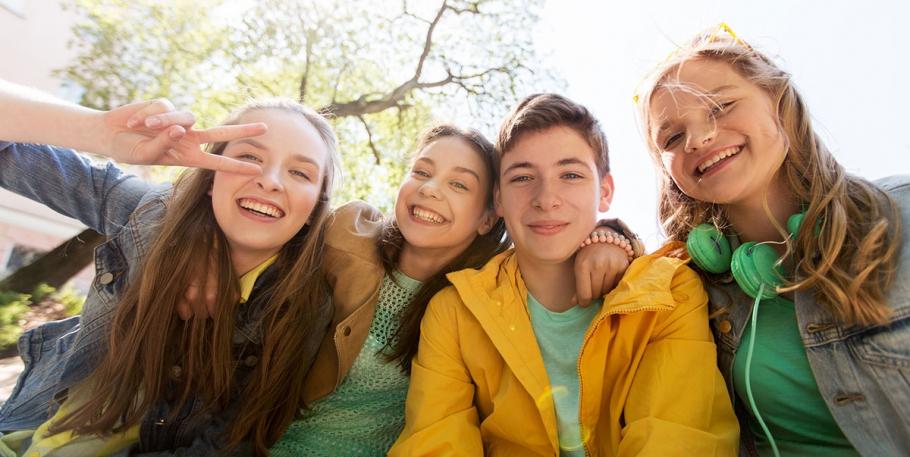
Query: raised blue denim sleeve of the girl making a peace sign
0 141 152 236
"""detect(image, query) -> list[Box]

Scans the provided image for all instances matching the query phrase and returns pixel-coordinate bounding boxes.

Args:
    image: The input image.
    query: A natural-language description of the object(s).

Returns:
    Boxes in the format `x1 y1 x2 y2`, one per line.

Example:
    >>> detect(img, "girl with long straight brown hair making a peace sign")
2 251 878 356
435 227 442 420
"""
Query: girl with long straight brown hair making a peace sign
0 83 337 456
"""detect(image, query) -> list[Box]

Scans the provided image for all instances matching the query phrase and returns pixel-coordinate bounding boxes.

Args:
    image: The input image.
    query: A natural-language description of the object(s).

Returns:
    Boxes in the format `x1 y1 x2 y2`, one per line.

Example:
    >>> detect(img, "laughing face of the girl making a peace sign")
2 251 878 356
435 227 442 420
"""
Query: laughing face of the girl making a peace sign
211 109 329 274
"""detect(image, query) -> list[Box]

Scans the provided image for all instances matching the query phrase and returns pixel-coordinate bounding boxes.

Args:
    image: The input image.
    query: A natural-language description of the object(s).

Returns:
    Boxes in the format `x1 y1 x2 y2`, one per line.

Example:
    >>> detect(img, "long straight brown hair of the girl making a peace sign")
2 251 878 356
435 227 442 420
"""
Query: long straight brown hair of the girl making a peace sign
53 100 337 455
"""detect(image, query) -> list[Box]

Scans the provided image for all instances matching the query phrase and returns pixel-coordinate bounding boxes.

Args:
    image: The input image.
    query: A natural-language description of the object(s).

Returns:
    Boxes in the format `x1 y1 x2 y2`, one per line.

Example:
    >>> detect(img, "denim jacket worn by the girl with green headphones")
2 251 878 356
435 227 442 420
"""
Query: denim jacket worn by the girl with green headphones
708 176 910 457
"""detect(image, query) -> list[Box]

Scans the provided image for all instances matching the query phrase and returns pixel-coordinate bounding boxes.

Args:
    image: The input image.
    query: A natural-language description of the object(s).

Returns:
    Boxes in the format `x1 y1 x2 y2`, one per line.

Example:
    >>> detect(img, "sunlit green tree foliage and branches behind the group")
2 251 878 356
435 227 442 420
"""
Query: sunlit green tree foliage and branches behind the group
59 0 562 209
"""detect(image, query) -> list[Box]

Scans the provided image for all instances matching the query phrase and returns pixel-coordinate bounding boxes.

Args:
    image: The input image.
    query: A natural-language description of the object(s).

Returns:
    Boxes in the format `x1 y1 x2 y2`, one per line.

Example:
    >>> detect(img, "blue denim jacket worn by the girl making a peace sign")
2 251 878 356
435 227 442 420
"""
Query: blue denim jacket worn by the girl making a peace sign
0 142 331 456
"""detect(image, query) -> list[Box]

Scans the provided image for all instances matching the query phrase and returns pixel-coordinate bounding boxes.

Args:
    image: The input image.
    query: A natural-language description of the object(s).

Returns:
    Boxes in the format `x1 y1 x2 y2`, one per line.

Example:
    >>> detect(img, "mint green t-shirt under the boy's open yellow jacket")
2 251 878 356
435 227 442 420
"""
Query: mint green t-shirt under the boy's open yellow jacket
528 292 603 457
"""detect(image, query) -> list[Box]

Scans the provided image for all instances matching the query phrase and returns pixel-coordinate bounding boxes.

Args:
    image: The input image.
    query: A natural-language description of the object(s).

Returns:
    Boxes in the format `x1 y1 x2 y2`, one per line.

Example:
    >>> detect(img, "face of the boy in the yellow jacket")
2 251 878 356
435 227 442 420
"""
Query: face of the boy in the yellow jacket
496 126 613 263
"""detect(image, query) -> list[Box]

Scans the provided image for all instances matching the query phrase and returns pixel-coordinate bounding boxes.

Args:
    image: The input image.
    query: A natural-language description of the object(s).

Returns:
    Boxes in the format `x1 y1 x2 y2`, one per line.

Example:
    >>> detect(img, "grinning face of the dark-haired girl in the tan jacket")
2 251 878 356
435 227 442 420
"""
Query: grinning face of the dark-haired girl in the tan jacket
395 136 493 258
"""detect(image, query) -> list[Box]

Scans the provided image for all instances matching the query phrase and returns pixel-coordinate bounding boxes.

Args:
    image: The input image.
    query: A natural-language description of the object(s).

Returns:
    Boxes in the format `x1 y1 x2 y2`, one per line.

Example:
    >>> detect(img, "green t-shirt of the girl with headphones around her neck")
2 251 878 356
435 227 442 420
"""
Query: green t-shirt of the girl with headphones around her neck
733 297 859 457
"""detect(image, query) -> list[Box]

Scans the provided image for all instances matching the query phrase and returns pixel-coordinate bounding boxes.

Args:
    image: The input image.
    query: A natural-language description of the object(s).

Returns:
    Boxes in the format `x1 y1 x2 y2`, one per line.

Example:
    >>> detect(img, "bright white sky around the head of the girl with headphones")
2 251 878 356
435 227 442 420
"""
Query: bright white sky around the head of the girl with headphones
536 0 910 249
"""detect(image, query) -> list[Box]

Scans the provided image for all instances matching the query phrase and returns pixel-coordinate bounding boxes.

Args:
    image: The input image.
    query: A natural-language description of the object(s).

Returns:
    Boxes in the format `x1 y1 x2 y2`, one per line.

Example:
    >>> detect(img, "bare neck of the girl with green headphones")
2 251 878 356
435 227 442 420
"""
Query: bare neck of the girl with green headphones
724 175 799 251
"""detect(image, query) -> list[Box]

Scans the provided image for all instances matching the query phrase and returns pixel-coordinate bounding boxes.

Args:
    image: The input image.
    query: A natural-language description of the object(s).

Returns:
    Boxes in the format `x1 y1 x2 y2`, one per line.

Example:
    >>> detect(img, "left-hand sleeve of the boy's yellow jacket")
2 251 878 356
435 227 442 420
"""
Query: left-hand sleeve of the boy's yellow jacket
389 287 483 456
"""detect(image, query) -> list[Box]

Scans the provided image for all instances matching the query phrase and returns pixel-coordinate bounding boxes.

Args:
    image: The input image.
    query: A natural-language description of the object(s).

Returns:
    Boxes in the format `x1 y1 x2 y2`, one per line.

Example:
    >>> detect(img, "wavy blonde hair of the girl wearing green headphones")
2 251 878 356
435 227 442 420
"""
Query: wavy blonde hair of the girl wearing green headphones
636 29 901 325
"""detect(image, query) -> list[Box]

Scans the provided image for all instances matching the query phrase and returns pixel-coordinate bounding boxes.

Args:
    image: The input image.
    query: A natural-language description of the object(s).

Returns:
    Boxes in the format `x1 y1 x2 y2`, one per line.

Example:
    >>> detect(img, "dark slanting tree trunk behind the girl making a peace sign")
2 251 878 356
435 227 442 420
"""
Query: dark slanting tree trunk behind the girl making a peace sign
0 229 104 294
